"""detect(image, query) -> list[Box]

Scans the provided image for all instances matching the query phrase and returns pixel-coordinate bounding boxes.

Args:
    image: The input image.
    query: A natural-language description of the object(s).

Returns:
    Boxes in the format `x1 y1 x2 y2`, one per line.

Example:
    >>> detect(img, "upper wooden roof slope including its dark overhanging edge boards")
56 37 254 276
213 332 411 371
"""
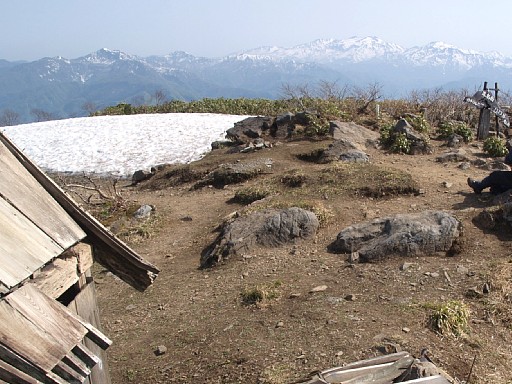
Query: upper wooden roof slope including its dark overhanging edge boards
0 133 159 294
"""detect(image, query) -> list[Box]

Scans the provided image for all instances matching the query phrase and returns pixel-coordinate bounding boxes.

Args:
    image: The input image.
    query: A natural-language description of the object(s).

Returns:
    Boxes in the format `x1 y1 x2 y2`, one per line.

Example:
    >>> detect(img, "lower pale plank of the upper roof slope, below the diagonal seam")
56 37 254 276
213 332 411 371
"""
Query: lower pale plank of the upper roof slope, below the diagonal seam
0 197 63 288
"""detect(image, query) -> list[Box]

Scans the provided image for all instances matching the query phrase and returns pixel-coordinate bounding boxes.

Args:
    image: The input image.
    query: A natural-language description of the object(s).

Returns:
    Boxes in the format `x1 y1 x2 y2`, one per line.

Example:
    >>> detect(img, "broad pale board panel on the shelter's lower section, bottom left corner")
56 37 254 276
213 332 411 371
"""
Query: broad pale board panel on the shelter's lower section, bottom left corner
0 284 87 372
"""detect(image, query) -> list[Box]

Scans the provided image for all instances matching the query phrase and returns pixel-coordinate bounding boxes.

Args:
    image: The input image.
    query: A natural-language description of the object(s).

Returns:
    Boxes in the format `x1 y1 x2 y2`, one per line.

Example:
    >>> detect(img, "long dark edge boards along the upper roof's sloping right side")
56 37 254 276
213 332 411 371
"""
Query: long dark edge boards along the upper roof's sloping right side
0 133 159 291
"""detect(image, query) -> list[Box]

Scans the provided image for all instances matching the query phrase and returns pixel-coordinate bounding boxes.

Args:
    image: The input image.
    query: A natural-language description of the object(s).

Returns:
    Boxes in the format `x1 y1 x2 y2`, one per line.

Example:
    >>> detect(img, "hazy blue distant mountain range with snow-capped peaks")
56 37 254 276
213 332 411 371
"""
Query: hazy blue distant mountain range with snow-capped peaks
0 37 512 122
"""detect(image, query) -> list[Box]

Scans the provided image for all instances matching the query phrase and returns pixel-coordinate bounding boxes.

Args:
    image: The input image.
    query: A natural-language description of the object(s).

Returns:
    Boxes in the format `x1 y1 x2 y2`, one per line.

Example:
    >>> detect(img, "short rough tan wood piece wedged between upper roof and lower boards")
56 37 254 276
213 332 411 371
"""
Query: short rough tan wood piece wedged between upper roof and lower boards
29 256 79 299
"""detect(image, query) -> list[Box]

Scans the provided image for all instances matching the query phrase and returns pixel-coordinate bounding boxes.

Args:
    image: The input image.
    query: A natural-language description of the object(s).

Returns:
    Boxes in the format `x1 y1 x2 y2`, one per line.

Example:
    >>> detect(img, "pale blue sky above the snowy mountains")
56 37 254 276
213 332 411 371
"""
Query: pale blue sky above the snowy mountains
0 0 512 61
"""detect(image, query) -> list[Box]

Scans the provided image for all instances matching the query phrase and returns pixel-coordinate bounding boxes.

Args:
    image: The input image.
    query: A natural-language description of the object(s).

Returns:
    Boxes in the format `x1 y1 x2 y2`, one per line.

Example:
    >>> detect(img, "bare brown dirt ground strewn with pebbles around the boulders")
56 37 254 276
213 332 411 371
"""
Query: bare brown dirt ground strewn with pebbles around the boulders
85 130 512 384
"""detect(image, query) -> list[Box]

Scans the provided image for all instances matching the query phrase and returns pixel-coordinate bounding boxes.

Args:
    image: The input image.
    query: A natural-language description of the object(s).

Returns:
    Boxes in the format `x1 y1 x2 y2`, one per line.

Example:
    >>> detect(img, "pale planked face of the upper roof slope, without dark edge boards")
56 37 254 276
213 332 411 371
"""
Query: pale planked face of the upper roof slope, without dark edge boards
0 136 86 292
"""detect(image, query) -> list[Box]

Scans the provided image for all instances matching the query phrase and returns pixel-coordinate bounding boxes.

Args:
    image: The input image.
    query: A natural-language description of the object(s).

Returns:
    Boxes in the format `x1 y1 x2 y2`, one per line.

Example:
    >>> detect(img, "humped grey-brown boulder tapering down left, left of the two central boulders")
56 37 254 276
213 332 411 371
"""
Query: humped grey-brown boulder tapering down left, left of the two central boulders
201 207 319 268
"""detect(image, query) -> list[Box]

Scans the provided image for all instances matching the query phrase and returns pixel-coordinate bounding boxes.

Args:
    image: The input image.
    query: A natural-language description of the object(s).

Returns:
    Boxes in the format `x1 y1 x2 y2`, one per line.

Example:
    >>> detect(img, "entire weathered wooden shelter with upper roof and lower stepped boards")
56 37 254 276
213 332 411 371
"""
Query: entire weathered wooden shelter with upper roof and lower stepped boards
0 132 159 384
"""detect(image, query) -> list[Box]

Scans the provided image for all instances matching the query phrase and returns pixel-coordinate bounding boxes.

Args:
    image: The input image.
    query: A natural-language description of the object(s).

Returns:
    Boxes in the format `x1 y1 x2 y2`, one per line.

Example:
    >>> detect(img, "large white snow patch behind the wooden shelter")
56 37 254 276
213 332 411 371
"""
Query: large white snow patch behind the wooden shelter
2 113 247 176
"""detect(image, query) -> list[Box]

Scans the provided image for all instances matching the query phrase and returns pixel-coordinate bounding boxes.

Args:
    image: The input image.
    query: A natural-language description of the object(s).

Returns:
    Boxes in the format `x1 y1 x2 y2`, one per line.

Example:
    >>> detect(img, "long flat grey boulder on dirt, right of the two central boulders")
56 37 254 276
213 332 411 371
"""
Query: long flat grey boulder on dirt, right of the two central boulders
329 211 462 261
